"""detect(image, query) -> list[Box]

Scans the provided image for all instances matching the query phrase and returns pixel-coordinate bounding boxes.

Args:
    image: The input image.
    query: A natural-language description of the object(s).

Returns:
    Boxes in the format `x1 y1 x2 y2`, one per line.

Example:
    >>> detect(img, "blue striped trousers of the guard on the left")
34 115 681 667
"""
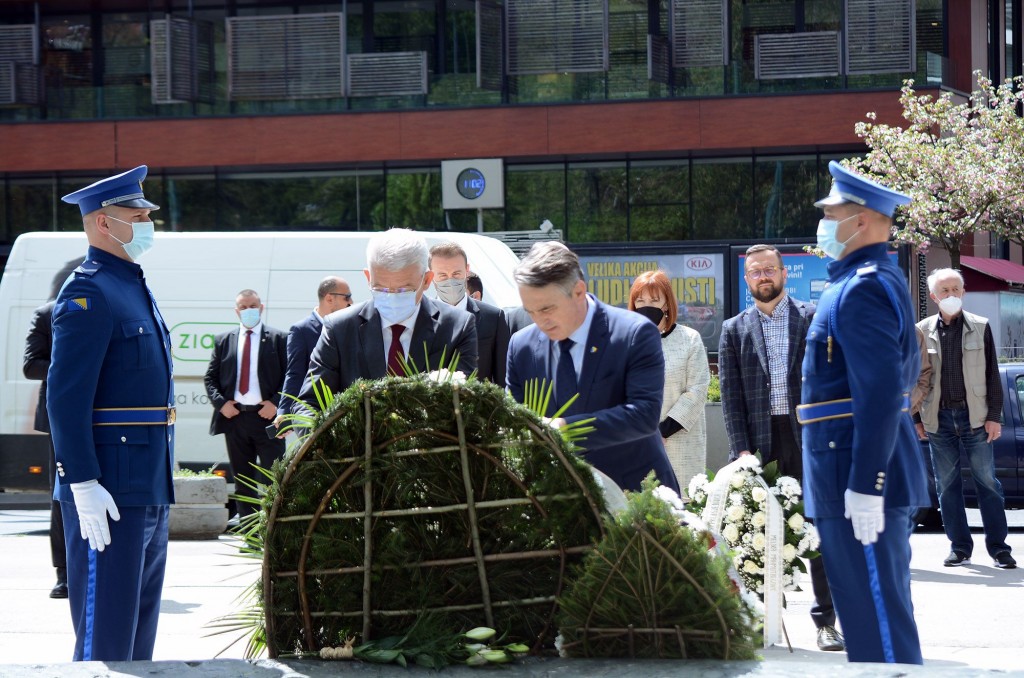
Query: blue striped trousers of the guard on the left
60 502 168 662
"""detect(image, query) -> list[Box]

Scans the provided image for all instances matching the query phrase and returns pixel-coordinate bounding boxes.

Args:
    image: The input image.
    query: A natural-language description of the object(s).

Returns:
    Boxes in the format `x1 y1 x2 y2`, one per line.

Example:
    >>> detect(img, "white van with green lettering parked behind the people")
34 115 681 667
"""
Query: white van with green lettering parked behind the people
0 231 520 490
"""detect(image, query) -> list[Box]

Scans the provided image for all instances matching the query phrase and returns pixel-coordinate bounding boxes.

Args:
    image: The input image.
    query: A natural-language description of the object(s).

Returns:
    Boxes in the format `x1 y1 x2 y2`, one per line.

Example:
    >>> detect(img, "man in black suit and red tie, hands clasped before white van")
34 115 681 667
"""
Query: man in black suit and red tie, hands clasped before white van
205 290 288 519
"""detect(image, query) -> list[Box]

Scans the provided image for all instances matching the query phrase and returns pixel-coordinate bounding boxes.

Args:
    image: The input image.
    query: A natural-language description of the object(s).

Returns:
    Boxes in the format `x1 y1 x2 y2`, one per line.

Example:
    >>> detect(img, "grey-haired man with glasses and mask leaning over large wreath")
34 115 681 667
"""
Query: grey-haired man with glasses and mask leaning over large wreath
299 228 477 409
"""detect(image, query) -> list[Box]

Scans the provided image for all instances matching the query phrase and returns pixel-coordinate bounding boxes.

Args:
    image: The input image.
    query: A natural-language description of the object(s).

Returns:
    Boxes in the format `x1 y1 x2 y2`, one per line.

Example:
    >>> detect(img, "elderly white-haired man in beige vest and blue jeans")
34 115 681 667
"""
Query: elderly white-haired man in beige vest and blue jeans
915 268 1017 569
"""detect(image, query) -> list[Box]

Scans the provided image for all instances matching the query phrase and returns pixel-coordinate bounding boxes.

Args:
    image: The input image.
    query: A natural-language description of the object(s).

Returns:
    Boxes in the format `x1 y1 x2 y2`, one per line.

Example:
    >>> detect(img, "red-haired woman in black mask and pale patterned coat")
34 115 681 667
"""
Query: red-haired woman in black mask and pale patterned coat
629 270 711 499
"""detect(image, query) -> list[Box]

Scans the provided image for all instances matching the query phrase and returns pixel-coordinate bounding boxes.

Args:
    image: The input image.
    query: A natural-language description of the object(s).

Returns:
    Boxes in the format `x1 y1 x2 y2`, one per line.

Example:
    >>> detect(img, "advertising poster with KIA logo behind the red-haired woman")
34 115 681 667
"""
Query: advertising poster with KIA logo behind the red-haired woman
580 253 725 352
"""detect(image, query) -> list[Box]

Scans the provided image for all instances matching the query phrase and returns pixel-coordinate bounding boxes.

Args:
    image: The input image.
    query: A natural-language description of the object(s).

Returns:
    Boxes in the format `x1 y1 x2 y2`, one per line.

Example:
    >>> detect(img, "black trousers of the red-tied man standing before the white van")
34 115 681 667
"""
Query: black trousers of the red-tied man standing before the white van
224 412 285 518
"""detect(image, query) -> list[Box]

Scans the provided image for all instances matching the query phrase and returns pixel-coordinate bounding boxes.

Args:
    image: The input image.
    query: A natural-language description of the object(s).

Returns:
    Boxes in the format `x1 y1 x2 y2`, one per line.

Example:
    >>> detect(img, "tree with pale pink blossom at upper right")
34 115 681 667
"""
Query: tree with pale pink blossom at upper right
846 72 1024 267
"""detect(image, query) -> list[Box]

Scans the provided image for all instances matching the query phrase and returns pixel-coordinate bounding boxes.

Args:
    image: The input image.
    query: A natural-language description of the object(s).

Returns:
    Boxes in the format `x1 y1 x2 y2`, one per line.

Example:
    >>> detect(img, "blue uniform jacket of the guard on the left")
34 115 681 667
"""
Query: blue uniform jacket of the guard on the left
46 247 174 506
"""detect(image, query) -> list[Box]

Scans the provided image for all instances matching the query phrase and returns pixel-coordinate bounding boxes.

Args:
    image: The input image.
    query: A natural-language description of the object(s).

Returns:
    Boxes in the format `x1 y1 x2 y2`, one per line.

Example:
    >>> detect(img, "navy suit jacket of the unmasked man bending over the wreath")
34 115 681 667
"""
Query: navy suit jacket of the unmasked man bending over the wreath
506 300 679 492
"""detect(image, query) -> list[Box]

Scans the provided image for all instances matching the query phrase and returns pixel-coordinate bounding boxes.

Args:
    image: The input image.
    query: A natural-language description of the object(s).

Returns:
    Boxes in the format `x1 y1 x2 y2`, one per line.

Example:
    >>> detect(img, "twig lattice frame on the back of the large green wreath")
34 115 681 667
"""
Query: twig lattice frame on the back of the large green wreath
261 378 604 658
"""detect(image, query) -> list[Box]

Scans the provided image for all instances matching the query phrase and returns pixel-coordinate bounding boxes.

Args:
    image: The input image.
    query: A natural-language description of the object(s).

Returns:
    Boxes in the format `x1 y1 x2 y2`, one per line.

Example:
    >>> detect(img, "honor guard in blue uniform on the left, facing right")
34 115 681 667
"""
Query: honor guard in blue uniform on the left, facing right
46 165 174 662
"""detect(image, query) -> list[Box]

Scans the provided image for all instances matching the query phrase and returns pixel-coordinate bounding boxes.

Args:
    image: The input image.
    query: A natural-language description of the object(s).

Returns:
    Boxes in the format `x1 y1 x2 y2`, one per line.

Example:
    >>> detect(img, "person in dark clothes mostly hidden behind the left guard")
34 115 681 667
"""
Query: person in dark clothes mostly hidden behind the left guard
23 300 68 598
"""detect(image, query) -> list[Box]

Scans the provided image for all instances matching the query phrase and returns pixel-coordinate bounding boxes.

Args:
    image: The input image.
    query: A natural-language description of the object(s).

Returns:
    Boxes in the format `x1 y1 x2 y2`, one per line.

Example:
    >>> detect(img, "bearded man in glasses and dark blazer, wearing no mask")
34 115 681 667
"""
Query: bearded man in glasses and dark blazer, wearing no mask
718 245 845 651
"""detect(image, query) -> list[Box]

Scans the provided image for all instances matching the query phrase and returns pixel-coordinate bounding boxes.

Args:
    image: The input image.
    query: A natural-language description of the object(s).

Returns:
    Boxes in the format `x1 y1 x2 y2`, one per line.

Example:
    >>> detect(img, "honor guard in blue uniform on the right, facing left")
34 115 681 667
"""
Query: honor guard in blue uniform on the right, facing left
798 162 929 664
